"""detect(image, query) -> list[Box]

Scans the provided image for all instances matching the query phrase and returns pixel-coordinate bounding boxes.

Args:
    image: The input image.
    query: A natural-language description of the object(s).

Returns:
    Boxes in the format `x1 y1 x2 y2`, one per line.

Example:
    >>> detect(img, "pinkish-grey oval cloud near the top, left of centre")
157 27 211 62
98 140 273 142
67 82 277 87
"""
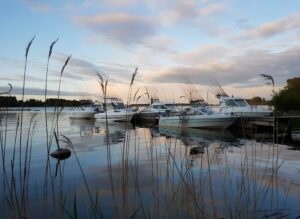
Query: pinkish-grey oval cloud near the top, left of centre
73 13 157 45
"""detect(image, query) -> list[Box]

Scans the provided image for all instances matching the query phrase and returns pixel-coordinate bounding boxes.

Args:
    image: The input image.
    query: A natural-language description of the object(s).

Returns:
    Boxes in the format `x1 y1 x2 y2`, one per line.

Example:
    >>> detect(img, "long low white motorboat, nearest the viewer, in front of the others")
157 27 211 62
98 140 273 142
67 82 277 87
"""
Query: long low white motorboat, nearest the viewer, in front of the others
159 108 239 129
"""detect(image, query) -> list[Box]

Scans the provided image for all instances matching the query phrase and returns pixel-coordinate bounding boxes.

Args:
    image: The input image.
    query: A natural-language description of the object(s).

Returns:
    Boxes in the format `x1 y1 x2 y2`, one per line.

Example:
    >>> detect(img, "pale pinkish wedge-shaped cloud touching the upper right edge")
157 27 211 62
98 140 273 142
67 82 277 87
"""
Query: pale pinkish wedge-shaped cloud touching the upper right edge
235 13 300 40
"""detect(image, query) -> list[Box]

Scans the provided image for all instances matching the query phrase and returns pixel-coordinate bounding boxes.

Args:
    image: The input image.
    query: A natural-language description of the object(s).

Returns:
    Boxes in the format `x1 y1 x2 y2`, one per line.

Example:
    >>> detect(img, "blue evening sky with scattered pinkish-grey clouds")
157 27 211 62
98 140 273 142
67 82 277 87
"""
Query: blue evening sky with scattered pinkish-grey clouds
0 0 300 102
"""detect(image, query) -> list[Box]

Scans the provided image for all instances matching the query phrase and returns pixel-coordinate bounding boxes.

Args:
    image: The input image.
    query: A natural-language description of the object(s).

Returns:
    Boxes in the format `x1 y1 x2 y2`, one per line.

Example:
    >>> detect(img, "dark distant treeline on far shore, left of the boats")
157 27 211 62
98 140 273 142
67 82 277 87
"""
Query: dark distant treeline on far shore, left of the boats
0 96 90 107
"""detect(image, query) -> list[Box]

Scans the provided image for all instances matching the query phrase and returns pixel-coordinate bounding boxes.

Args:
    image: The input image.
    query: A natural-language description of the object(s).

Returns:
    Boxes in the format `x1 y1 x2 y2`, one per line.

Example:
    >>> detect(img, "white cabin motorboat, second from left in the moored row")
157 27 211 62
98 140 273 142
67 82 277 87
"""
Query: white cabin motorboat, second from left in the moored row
95 97 134 122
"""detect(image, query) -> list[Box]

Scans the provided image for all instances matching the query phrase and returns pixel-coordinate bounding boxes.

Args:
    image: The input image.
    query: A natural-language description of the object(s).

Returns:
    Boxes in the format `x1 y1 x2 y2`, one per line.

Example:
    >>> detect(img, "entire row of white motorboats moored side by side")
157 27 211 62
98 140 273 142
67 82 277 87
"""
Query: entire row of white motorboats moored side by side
70 96 272 129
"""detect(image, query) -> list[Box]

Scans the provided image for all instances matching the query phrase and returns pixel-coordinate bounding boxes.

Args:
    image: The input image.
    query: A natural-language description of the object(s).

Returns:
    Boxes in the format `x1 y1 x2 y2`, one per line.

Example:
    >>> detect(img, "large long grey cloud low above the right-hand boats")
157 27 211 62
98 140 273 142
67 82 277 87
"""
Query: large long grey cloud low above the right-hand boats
147 47 300 87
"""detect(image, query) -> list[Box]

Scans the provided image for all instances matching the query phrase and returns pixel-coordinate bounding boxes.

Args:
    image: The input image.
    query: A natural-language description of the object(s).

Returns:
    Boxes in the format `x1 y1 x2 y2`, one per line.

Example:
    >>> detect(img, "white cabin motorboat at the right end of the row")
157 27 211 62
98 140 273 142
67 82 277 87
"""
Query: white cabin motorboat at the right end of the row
219 96 272 118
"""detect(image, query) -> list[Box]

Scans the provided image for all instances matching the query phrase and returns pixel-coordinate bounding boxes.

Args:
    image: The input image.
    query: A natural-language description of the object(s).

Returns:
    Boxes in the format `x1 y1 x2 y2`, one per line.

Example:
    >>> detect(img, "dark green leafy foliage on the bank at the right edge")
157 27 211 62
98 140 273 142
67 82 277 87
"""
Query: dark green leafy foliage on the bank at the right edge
272 77 300 111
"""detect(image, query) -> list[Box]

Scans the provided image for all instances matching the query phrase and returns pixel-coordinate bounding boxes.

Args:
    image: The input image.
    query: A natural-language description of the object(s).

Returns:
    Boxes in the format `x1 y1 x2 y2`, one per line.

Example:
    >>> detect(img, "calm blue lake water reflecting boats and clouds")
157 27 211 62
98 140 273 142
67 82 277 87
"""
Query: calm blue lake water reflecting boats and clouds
0 111 300 218
